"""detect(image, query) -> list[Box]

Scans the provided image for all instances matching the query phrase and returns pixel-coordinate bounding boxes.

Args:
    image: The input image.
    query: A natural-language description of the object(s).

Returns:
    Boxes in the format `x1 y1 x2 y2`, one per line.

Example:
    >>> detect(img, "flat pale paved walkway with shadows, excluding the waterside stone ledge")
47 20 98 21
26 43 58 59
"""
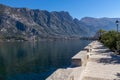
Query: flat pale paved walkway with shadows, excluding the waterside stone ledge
79 41 120 80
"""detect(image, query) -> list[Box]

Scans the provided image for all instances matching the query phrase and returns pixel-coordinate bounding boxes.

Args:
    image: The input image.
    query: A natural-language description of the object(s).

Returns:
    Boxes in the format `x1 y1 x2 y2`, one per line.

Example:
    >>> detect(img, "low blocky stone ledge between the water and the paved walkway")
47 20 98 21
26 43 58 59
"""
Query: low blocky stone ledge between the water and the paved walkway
46 41 94 80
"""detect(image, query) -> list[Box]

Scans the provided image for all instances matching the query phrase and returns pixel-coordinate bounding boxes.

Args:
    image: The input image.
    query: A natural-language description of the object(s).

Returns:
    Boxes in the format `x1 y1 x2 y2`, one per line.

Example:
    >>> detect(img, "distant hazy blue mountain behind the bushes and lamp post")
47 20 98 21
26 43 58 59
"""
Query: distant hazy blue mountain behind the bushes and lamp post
80 17 120 35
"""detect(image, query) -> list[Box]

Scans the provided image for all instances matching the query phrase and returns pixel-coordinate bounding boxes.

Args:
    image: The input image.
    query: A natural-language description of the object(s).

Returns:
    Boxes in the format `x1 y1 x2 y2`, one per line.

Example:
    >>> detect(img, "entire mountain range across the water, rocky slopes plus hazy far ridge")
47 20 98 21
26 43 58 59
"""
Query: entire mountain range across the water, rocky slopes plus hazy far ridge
0 4 117 40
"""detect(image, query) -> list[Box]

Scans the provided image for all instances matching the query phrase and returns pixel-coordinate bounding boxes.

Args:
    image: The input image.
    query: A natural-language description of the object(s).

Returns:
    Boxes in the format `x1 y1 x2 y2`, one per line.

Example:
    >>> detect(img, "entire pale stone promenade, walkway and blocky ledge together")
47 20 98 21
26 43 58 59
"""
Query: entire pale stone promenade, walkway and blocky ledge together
46 41 120 80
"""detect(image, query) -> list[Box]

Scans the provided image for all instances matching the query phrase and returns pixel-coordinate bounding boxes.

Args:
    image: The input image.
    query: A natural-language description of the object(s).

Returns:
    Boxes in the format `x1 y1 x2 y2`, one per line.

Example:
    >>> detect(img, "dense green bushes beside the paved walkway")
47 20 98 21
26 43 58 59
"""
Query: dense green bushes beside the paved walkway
99 30 120 53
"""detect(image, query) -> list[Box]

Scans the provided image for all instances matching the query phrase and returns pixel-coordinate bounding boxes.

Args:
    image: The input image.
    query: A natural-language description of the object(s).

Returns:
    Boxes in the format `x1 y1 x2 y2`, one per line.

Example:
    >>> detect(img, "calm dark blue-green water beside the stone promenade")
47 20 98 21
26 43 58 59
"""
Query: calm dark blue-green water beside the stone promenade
0 40 89 80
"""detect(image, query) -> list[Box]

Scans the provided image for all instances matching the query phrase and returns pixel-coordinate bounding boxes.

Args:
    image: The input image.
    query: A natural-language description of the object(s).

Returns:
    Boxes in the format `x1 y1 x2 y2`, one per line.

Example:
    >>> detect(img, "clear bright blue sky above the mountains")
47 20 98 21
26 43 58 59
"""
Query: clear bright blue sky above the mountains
0 0 120 19
